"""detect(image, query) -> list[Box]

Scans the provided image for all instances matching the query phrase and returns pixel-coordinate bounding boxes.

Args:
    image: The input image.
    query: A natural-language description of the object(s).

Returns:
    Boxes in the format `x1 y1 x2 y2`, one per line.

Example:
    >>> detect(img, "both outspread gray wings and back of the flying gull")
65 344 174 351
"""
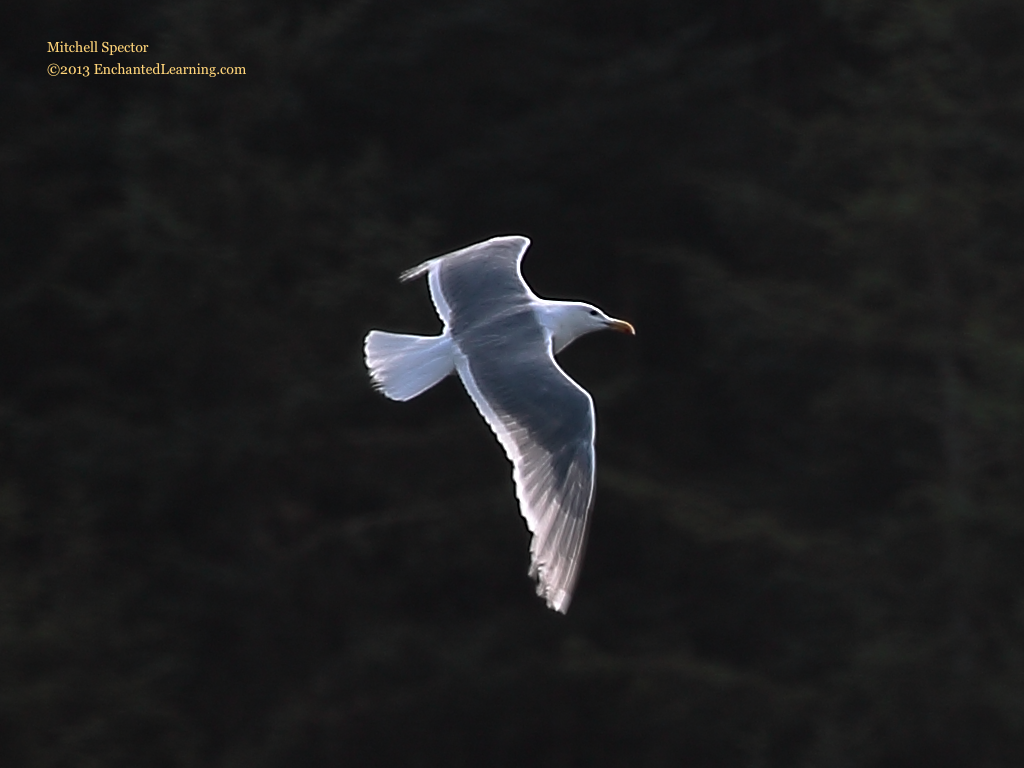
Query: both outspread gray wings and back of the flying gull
403 237 595 612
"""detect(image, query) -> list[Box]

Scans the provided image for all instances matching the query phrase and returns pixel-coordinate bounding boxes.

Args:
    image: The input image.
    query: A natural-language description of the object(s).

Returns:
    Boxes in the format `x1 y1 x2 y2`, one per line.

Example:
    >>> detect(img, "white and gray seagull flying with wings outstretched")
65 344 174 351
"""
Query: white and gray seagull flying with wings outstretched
364 236 636 613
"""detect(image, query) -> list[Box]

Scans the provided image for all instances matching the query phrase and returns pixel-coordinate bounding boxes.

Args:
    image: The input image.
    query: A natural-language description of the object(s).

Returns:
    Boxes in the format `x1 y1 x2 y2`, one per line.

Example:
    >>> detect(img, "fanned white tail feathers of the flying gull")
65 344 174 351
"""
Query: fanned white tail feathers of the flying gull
364 331 455 400
